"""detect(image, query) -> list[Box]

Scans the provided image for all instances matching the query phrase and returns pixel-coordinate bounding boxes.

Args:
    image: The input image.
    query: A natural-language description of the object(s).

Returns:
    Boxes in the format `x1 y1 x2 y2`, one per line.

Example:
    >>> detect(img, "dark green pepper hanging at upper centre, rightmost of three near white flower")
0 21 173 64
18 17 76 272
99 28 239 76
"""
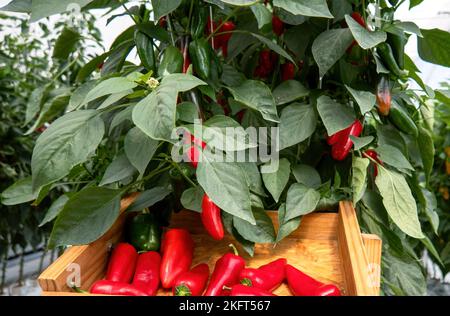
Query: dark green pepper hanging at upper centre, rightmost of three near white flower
189 38 212 80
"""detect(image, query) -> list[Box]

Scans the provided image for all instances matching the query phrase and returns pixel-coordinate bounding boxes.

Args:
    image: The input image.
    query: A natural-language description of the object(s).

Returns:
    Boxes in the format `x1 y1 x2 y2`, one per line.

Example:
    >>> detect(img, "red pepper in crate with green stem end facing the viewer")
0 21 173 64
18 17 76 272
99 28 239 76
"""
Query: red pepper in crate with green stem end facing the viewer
172 263 209 296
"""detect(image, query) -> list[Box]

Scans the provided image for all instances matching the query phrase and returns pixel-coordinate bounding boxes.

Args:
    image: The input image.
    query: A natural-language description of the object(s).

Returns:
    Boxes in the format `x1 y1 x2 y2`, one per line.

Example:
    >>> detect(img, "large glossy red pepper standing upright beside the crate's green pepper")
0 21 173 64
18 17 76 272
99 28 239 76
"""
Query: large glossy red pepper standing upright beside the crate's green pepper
160 228 194 289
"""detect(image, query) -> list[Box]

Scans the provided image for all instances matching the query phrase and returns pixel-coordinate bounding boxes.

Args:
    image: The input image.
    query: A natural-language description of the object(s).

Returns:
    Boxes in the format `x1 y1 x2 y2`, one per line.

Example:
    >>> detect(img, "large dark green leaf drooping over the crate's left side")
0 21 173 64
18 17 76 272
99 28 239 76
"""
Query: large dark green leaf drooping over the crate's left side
49 187 123 248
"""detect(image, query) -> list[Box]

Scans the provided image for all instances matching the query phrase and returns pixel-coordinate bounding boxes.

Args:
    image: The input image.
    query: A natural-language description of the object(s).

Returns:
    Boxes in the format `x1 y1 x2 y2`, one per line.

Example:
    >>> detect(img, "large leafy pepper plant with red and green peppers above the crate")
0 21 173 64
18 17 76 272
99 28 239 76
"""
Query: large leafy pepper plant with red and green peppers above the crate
1 0 450 295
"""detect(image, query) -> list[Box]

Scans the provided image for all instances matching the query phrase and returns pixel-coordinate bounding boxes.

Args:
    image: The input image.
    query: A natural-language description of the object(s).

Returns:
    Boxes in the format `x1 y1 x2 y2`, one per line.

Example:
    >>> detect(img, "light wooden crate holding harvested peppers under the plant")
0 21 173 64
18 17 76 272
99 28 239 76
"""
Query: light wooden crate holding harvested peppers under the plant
39 196 381 296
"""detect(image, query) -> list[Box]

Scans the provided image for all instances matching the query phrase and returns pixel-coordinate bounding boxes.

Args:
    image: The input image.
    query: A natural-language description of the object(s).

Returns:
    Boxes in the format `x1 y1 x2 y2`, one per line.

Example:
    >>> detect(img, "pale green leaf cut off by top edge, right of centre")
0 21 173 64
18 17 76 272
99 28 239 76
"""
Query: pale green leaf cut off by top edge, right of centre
273 0 333 18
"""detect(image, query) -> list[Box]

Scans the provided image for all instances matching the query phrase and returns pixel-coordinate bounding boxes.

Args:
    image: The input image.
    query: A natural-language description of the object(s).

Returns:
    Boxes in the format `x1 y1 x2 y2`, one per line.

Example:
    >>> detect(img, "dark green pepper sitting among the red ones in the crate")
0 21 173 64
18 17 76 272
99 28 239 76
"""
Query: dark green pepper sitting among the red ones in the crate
126 213 161 251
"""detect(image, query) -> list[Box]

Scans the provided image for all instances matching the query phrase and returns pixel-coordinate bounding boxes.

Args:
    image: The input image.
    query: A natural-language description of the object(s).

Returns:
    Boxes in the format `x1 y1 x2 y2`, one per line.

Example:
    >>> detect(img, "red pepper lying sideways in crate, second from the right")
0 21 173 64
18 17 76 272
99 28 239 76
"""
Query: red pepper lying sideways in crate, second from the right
239 258 287 292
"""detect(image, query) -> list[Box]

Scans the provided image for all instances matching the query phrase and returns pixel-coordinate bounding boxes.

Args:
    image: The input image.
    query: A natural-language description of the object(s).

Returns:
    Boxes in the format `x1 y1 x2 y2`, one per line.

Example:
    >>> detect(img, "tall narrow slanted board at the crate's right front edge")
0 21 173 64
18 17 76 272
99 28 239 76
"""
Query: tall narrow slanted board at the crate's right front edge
338 201 373 296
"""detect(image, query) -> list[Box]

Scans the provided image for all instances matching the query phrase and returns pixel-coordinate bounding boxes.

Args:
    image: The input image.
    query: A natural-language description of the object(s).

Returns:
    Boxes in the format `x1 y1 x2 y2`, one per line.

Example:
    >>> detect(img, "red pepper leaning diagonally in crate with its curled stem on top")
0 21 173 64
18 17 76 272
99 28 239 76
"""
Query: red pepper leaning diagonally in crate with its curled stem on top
205 245 245 296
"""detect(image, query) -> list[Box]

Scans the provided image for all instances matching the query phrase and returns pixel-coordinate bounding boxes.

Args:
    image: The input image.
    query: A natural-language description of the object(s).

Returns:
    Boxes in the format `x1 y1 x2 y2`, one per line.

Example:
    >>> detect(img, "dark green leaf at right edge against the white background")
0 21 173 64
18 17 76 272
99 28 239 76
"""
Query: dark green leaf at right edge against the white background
417 29 450 67
